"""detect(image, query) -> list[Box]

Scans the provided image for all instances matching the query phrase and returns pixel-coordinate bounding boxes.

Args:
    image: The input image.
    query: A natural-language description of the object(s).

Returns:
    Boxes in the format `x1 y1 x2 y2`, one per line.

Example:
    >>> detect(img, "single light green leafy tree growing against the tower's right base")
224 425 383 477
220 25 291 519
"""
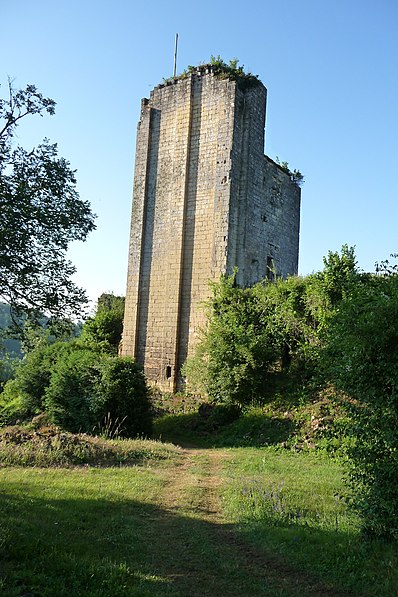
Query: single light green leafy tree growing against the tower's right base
183 275 280 404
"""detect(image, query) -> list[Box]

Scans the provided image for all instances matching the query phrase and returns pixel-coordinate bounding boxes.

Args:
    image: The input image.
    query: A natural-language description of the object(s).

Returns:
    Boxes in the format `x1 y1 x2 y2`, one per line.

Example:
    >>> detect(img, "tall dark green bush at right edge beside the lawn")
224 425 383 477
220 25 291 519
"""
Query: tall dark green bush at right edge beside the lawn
321 275 398 538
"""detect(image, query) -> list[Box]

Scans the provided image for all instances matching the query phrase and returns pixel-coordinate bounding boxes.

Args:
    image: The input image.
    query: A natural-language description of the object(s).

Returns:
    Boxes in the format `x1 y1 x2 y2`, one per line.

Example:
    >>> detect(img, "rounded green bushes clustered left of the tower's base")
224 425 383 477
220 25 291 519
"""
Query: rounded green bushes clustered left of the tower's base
0 340 151 437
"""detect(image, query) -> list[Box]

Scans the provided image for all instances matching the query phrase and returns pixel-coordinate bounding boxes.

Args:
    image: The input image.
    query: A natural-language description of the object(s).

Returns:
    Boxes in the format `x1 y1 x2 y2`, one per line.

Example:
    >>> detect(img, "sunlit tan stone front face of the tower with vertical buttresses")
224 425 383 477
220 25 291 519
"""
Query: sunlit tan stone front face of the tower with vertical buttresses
122 73 239 390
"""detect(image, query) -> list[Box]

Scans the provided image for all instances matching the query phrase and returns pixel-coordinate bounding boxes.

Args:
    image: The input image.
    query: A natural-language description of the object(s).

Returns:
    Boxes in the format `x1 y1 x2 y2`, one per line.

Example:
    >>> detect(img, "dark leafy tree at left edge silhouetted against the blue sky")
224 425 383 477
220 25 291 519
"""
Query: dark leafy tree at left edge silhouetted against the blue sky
0 82 95 318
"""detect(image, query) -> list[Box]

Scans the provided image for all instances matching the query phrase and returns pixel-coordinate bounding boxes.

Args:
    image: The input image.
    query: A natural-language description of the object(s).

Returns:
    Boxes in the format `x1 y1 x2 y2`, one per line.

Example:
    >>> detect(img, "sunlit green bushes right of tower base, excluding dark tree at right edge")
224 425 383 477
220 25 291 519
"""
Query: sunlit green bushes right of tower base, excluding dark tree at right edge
183 245 360 405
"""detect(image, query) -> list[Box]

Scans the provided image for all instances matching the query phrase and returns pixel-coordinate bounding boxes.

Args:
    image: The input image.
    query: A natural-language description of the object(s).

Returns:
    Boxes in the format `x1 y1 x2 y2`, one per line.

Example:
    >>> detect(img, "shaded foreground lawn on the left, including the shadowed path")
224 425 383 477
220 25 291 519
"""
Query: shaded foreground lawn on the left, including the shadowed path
0 486 360 597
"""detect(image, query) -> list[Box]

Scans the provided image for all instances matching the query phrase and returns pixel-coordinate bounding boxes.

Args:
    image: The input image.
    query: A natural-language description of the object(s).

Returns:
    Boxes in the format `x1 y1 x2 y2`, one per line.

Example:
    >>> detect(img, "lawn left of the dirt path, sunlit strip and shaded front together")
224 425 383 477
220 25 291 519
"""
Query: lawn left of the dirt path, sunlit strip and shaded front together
0 457 318 597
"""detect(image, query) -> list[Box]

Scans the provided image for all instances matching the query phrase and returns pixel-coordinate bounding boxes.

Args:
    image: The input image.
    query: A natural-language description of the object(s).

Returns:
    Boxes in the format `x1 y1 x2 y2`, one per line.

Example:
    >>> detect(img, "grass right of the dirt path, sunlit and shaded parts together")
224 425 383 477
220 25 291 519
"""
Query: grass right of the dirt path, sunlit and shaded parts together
223 448 398 597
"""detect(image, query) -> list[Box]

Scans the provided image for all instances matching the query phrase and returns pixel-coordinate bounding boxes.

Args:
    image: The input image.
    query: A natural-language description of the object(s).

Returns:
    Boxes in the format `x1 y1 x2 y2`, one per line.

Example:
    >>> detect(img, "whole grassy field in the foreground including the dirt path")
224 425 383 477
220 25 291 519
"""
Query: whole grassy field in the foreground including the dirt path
0 421 398 597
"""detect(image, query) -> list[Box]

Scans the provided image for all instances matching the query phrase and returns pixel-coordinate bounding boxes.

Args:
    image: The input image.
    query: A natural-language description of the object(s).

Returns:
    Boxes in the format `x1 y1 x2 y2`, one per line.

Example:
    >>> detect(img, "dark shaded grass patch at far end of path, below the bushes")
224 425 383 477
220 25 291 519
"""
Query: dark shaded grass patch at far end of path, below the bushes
153 412 296 448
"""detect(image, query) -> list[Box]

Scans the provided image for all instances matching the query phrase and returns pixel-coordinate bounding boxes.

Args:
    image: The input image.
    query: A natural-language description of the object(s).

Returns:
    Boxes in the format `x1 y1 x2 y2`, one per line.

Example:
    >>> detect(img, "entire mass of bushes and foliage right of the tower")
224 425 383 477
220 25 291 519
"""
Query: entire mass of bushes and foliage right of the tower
185 246 398 539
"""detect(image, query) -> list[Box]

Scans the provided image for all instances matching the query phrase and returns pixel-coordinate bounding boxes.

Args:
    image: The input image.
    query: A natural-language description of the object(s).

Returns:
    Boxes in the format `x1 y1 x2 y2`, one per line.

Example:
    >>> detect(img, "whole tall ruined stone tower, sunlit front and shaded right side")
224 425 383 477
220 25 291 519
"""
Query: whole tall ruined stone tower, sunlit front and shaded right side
122 66 300 391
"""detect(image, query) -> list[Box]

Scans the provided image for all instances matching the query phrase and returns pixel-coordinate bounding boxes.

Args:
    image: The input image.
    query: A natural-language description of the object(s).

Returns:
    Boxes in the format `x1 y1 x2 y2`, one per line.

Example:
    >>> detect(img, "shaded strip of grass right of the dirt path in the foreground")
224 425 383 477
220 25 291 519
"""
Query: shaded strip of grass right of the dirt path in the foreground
233 519 398 597
